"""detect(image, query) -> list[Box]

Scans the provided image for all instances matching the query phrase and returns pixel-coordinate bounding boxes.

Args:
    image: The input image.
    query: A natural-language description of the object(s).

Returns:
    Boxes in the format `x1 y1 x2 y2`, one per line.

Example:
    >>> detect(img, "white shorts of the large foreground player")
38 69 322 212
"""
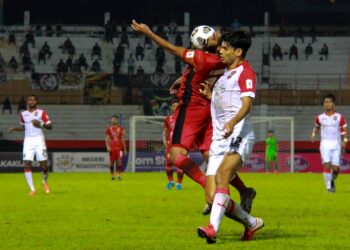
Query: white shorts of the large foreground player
207 132 254 176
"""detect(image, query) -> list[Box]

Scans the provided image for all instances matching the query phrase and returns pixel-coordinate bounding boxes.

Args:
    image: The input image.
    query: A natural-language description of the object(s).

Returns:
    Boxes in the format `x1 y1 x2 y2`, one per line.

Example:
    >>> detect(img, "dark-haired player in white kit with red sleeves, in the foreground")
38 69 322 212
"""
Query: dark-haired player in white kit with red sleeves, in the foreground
197 31 264 243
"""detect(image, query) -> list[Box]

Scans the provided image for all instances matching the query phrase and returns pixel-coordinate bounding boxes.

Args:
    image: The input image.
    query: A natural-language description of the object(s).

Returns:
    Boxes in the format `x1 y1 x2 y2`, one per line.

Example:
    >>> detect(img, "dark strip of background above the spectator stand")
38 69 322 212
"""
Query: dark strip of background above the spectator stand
3 0 350 25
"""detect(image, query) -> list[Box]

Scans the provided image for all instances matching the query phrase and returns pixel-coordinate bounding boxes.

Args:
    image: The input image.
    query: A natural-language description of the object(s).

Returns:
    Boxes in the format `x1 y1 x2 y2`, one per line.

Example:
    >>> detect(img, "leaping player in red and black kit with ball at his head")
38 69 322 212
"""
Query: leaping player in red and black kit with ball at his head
131 20 255 217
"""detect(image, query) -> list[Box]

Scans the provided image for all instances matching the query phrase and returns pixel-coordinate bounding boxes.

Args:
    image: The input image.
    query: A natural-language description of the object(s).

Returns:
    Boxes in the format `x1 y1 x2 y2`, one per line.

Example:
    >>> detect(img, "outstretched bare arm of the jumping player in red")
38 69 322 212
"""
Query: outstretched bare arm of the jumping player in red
131 20 186 58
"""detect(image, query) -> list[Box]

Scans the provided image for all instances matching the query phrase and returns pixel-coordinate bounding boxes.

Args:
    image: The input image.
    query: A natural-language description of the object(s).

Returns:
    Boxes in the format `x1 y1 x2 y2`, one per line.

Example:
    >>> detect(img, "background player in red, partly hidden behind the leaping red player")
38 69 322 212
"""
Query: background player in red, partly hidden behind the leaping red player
163 98 184 190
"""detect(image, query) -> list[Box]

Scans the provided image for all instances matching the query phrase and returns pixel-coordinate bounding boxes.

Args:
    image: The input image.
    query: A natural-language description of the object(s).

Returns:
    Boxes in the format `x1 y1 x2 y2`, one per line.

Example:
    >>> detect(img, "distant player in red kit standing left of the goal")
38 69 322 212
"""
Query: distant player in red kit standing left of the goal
105 115 127 180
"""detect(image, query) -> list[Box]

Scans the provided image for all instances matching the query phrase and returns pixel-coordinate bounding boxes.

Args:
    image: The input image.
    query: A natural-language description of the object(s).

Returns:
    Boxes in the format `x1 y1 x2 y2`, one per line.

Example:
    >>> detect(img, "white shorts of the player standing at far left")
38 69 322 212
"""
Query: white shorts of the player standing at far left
23 137 47 161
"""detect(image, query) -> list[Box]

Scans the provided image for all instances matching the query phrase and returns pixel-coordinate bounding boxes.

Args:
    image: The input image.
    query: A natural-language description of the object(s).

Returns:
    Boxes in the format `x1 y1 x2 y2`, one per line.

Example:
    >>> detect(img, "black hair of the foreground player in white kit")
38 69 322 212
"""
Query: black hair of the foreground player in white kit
220 30 252 58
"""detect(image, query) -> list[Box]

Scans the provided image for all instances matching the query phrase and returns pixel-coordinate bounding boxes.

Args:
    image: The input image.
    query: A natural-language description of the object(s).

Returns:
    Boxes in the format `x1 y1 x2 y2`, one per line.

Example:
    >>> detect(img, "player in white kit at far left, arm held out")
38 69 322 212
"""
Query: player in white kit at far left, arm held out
9 95 52 196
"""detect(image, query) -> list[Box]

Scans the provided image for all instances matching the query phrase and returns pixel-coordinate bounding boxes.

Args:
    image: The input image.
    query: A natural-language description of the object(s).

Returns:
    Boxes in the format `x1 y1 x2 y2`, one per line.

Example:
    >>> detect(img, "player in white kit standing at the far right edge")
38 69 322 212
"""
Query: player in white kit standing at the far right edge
311 94 348 193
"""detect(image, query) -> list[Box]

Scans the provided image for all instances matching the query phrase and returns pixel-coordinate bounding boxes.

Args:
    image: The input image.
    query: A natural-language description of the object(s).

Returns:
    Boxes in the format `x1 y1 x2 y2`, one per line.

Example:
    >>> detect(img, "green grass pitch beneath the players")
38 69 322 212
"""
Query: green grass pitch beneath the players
0 173 350 250
